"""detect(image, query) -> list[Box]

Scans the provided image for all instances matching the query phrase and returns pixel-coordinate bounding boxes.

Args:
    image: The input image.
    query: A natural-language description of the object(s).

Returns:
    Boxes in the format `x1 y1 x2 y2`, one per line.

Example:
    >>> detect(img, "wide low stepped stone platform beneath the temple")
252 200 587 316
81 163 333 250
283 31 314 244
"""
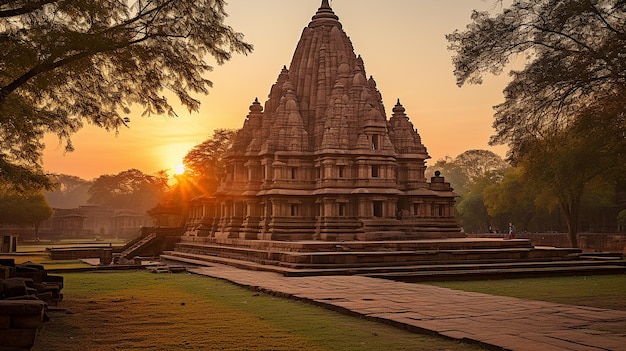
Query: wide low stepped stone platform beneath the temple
161 237 626 281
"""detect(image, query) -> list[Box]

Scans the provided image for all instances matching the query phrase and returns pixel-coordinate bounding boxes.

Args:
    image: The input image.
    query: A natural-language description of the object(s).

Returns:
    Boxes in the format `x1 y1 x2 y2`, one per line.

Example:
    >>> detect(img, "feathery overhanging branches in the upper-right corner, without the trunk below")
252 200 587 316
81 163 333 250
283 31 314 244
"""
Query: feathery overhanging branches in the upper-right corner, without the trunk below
447 0 626 156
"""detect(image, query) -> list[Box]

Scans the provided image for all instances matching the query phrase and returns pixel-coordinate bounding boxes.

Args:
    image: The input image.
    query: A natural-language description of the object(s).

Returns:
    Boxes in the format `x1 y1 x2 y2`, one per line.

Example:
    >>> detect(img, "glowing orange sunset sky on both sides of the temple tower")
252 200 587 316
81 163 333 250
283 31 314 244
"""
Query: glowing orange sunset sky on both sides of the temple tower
44 0 507 179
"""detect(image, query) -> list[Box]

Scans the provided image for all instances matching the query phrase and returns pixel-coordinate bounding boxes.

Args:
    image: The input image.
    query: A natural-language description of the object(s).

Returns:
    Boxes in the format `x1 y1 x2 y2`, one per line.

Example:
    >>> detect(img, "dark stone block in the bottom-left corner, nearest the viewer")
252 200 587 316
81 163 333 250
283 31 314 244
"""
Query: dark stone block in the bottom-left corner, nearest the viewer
0 300 46 351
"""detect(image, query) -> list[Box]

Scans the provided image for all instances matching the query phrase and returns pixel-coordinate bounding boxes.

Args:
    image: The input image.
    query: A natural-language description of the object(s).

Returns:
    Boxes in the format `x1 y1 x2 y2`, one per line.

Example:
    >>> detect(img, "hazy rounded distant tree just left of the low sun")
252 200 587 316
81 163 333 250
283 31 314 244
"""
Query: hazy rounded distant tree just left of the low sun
88 169 168 212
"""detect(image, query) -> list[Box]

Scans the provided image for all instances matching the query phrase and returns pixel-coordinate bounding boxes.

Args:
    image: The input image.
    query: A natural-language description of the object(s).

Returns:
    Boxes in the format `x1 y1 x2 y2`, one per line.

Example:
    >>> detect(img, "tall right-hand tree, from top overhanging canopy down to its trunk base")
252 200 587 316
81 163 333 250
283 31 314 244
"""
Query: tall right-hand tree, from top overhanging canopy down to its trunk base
447 0 626 246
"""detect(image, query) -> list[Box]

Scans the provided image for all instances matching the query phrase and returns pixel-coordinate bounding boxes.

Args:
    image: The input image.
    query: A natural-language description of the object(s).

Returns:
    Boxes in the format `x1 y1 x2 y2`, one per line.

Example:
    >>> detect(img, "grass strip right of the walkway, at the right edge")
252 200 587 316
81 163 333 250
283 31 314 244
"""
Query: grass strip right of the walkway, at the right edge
426 274 626 311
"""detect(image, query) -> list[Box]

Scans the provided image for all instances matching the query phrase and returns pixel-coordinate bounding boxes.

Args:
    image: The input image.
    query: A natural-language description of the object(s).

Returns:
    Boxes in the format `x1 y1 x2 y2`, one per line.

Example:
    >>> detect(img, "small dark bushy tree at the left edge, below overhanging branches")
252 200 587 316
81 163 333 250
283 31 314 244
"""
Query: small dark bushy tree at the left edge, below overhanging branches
0 190 53 238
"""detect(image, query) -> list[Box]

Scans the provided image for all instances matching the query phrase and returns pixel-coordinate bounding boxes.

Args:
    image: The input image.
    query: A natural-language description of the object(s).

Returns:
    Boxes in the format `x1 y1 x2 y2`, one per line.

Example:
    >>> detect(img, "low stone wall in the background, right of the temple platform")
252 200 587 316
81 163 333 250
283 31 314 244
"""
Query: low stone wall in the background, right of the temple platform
467 233 626 253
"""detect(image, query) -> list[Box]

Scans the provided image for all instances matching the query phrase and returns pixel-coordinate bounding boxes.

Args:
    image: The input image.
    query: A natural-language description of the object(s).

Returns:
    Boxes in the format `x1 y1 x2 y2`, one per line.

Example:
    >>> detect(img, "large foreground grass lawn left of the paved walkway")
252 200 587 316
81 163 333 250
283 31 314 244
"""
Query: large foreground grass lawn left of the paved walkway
33 271 480 351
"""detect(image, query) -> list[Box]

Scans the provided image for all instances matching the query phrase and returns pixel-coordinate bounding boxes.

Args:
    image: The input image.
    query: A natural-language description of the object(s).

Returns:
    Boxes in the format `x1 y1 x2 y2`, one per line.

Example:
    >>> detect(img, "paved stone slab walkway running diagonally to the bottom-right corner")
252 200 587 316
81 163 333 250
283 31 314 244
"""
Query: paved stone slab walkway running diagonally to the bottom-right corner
190 266 626 351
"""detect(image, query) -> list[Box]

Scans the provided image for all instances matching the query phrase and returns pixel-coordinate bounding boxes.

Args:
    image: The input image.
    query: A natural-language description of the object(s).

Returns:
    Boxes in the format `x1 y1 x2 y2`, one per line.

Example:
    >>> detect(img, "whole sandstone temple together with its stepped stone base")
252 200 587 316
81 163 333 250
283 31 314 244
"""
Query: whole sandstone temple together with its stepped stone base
161 0 596 279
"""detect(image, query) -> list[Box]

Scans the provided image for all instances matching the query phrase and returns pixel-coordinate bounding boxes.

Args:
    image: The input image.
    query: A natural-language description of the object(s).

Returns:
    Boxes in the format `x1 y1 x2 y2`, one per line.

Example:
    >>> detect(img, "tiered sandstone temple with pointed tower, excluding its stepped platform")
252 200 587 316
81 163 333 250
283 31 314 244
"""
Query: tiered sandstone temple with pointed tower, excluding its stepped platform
186 0 464 242
